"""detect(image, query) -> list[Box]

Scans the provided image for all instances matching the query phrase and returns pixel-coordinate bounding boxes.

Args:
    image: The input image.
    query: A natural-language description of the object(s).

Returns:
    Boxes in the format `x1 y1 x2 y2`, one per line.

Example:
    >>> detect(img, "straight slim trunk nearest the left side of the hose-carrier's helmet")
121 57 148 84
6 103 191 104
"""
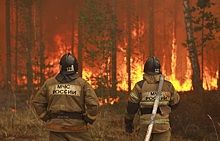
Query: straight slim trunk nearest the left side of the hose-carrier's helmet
127 0 131 92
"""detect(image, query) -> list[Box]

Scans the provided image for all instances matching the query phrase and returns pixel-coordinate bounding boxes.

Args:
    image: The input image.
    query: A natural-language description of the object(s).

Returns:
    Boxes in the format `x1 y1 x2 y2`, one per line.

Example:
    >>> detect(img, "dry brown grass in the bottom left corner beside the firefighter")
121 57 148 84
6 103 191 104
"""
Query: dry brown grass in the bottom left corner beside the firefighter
0 107 47 141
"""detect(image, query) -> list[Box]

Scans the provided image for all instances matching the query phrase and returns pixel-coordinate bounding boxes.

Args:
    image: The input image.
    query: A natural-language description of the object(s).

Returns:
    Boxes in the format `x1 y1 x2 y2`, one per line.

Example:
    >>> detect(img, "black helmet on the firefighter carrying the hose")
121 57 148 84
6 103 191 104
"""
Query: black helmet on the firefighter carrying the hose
144 57 161 75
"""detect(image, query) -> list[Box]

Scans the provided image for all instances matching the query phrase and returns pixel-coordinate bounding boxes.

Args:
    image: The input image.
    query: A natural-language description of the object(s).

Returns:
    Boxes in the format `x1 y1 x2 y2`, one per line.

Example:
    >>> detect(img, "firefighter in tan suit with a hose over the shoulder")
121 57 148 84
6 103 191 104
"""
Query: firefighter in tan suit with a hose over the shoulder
124 57 180 141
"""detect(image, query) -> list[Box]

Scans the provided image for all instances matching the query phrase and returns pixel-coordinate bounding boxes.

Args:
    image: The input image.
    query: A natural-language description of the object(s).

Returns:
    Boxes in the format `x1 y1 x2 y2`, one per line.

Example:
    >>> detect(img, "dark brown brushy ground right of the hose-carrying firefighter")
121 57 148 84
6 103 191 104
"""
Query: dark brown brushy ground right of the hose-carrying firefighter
171 91 220 141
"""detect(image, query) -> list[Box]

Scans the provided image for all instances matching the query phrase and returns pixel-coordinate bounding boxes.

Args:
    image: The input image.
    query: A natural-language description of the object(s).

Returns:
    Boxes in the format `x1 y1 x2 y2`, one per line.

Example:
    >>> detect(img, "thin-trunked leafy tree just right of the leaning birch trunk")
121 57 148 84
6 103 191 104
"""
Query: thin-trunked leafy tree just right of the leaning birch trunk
192 0 220 88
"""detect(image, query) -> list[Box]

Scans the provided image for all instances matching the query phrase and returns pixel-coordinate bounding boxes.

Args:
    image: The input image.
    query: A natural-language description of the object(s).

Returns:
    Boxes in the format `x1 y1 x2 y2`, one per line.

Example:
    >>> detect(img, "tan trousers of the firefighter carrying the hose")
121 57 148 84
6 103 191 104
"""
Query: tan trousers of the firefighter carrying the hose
136 128 171 141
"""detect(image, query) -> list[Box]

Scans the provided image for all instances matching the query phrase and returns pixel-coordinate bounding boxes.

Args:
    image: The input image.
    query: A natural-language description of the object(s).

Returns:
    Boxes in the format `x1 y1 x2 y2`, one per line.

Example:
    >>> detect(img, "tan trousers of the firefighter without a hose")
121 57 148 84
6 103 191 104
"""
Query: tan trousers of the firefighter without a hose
49 131 92 141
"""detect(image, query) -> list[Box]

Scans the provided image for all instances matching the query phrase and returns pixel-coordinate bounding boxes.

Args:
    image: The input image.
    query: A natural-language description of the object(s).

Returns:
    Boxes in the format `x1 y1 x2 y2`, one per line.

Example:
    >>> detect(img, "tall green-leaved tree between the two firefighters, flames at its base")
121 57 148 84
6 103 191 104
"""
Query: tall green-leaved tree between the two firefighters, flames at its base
78 0 118 97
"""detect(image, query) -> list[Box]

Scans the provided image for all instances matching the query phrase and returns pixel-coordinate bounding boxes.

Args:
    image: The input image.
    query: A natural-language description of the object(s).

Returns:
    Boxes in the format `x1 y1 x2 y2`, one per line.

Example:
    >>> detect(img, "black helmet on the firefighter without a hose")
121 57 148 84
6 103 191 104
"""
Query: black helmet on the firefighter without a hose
60 53 78 74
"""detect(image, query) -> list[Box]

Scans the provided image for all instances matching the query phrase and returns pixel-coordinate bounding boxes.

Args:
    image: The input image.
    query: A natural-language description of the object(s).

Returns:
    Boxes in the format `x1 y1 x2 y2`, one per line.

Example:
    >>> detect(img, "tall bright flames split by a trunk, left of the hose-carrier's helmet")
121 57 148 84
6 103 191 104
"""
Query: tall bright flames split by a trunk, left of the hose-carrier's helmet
117 22 145 91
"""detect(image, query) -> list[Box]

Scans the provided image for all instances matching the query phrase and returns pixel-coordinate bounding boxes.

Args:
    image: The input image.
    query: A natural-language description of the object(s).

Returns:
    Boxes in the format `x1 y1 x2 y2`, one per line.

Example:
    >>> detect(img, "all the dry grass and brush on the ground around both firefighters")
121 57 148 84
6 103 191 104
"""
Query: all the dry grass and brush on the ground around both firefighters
0 91 220 141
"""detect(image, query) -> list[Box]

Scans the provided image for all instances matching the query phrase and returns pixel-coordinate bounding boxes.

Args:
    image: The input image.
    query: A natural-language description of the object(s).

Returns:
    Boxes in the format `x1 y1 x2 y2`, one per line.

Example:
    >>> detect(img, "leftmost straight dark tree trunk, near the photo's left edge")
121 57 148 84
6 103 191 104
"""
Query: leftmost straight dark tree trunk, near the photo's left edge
5 0 11 92
